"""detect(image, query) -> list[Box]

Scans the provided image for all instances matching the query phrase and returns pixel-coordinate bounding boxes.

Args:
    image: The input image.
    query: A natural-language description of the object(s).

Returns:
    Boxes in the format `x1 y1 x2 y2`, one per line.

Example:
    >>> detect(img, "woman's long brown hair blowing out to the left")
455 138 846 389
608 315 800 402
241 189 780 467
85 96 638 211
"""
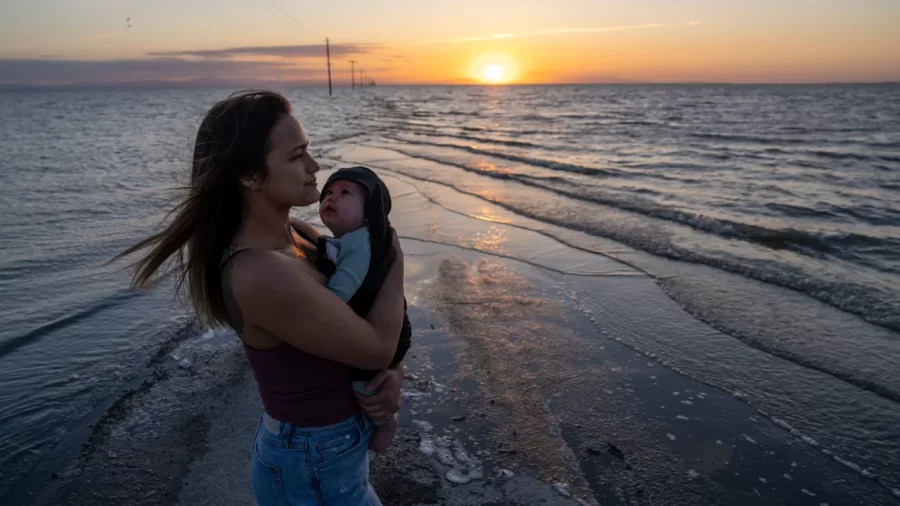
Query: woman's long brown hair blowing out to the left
116 90 291 325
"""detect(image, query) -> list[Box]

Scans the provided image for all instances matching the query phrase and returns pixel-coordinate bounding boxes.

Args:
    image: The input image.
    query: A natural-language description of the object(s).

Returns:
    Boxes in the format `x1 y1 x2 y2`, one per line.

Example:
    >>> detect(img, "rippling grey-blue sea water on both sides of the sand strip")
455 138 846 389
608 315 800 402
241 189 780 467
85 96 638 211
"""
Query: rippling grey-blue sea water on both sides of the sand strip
0 85 900 496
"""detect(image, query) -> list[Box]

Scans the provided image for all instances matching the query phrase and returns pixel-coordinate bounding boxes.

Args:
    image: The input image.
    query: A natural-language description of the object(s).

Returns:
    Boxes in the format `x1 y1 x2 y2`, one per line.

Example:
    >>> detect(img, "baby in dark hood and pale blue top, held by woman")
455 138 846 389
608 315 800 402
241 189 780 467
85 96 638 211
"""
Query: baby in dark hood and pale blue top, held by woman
317 167 412 453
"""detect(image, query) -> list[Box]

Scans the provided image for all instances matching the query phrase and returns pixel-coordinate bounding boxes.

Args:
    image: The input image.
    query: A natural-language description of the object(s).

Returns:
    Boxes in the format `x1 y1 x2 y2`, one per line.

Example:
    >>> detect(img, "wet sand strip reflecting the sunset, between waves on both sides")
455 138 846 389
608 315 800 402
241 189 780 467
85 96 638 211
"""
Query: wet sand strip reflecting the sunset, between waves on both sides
19 168 897 506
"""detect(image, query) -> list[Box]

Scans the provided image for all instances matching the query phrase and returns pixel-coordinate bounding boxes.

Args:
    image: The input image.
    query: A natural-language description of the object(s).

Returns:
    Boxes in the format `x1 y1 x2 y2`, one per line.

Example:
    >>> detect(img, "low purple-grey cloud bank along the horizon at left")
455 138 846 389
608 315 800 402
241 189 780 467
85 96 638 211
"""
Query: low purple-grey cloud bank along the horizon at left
0 58 324 85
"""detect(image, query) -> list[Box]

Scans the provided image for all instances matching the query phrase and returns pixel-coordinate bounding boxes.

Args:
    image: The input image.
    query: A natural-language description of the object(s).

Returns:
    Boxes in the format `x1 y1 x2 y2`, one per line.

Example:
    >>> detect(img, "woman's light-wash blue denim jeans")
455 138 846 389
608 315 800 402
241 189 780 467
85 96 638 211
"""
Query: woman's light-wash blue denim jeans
251 413 381 506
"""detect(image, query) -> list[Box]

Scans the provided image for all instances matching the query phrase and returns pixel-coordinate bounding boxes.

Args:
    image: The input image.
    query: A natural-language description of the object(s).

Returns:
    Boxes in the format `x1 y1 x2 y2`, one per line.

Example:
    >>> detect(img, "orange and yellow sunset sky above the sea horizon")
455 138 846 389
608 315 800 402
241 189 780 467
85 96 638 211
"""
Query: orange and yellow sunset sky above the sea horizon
0 0 900 85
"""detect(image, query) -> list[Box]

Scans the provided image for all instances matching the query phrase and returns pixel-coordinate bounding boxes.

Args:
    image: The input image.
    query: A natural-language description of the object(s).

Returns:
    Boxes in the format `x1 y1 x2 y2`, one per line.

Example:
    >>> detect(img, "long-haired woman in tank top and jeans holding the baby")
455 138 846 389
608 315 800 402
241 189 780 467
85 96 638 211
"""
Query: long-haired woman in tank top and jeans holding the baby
123 91 403 506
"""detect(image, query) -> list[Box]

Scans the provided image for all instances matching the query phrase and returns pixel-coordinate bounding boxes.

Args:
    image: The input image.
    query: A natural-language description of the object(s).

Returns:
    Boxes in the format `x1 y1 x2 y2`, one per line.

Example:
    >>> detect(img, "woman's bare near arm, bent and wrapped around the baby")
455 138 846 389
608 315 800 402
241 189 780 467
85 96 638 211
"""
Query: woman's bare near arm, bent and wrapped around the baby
231 238 403 369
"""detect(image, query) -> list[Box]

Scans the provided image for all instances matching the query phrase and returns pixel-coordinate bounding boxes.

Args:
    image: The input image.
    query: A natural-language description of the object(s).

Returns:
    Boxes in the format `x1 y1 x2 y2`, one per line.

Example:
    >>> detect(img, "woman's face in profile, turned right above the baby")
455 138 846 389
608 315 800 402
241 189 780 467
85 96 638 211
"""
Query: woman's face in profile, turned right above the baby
259 114 319 207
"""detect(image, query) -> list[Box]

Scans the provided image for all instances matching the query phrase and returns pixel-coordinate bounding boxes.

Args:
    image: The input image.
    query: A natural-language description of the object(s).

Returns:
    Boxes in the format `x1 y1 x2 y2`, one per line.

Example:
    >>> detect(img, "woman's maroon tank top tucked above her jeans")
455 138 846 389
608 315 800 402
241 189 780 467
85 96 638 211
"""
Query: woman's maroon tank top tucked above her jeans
222 243 359 427
